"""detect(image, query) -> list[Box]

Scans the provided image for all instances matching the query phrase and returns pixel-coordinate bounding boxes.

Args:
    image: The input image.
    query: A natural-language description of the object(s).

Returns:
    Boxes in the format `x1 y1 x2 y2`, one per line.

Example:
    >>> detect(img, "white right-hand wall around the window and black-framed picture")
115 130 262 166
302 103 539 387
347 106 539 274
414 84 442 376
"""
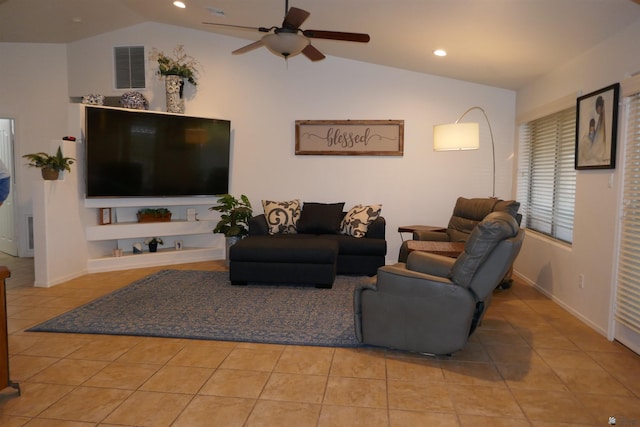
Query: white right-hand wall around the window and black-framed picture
515 21 640 344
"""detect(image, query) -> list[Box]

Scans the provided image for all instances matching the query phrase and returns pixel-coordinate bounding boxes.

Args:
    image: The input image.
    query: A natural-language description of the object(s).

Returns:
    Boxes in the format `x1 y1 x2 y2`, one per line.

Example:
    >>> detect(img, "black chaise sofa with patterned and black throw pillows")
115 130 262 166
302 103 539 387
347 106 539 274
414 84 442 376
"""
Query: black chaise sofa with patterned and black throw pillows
229 200 387 287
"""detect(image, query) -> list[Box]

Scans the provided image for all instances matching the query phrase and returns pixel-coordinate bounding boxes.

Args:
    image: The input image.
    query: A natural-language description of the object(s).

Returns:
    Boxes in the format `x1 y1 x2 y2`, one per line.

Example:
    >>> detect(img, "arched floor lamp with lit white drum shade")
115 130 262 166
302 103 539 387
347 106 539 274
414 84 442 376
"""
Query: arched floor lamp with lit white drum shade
433 107 496 197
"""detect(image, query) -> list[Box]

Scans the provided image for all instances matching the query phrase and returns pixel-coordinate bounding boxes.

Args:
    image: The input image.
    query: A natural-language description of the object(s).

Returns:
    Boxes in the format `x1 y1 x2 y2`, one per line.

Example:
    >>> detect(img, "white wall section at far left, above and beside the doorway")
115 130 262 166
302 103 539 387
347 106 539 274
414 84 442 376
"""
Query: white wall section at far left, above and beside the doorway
0 43 69 256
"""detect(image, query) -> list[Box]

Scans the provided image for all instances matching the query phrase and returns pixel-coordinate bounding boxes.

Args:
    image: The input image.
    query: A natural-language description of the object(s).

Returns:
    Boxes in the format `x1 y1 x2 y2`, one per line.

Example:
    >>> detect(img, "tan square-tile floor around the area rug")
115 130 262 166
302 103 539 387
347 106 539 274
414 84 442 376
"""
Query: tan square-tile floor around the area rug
0 257 640 427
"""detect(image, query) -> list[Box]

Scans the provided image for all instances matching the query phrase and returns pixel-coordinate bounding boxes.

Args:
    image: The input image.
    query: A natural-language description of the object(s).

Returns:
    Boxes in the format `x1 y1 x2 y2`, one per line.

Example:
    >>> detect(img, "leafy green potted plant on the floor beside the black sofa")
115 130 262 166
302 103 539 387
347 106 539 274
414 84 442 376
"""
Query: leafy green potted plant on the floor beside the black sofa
209 194 253 261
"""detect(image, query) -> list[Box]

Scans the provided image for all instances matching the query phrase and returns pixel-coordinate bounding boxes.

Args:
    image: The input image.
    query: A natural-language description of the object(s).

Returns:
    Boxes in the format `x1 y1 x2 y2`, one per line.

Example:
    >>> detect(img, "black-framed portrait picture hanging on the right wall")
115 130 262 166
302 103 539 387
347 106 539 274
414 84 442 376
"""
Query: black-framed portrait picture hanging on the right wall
575 83 620 169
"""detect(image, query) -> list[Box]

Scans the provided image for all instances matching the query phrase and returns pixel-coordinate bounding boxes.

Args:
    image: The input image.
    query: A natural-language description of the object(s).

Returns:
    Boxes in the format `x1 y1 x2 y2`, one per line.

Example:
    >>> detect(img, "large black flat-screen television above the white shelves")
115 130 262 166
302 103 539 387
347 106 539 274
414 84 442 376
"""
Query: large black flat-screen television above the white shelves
85 106 231 198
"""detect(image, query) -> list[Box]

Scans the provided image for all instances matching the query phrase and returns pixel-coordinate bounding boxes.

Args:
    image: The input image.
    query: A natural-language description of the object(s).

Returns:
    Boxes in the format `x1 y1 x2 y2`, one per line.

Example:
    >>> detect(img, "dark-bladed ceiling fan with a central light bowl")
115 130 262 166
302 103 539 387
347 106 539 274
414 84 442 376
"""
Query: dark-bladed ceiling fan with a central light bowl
203 0 370 61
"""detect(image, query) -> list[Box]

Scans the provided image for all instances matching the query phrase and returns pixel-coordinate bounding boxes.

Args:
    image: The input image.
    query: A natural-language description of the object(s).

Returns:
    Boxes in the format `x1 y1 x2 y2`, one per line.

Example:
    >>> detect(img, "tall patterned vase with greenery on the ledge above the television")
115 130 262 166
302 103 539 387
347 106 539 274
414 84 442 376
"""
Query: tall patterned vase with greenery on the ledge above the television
149 45 198 113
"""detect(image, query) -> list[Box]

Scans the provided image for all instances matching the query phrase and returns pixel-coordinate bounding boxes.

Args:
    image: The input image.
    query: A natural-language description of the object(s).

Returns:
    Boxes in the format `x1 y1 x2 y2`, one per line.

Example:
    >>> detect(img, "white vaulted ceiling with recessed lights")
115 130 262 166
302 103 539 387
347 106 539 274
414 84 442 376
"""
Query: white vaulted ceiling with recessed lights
0 0 640 90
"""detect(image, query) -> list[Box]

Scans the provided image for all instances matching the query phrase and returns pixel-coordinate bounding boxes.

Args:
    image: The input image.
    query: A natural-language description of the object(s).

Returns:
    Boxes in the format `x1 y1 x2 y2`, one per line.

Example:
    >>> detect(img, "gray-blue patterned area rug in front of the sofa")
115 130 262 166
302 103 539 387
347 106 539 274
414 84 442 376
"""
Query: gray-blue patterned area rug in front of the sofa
28 270 372 347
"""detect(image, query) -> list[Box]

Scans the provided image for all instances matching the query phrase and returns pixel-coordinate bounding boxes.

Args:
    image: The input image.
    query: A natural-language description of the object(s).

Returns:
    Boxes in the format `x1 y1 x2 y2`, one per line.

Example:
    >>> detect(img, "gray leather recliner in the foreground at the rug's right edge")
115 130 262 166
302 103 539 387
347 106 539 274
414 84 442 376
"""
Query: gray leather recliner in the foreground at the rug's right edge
354 212 524 355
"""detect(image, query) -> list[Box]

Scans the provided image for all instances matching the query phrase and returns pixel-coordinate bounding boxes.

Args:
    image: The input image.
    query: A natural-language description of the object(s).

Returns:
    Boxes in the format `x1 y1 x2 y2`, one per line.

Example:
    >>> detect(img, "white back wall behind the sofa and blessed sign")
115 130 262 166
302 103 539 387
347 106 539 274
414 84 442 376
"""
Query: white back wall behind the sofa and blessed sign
68 24 515 268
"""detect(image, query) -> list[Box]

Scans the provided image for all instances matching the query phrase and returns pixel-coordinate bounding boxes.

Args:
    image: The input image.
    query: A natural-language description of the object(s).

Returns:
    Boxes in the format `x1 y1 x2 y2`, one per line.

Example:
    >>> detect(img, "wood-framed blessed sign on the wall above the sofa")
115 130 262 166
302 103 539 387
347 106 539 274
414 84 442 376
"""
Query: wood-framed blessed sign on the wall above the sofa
296 120 404 156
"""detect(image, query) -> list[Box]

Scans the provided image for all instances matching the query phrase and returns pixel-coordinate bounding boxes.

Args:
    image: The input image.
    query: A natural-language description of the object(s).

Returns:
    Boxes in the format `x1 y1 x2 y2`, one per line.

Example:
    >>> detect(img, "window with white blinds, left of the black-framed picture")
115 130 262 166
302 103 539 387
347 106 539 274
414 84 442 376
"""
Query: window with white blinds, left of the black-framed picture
517 107 576 243
